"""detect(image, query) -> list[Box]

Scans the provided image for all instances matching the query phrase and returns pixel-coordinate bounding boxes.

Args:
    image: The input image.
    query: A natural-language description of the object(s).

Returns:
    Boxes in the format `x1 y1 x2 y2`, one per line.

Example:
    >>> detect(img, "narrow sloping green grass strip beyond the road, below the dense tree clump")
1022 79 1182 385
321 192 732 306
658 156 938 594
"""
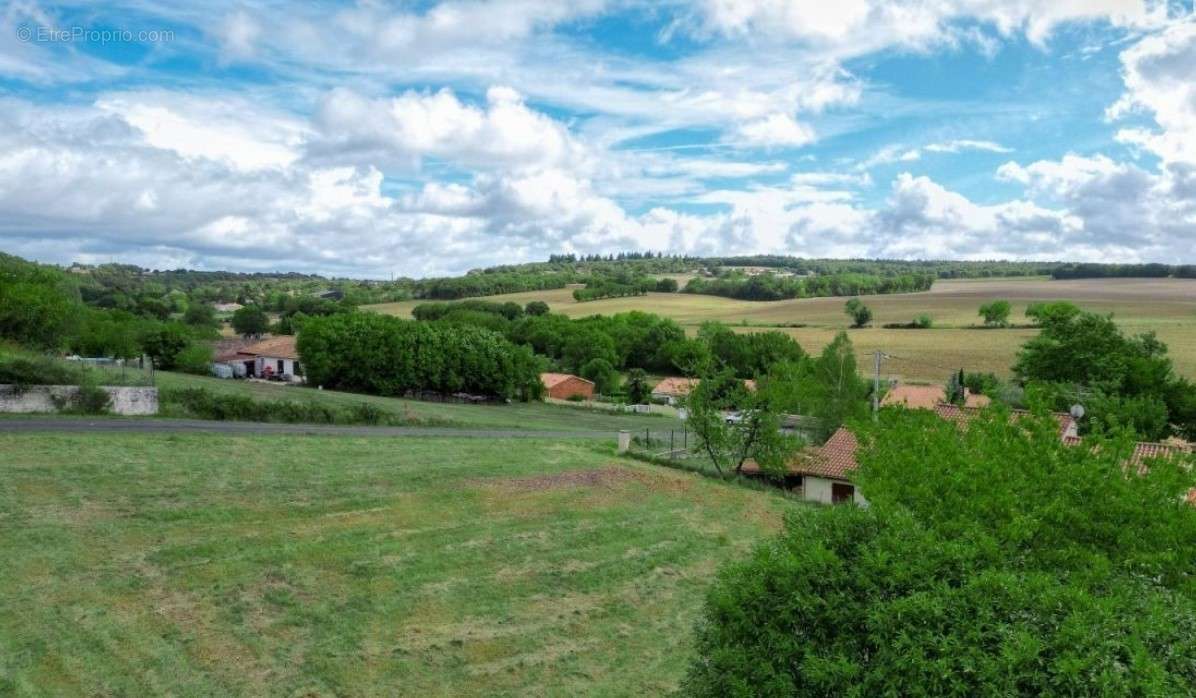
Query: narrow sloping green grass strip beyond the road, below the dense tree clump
155 372 681 431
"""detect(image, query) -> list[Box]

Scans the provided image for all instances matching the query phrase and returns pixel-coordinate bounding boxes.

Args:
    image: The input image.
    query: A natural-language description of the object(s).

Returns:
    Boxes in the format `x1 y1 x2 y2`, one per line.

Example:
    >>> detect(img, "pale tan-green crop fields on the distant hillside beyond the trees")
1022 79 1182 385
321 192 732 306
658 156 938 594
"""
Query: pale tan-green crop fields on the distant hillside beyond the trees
370 278 1196 381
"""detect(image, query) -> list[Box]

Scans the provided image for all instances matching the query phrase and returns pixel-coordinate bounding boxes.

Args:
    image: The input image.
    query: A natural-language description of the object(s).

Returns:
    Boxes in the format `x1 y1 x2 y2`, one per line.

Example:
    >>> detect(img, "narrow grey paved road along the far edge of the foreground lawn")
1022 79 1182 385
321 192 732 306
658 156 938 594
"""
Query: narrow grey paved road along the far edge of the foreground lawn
0 417 631 439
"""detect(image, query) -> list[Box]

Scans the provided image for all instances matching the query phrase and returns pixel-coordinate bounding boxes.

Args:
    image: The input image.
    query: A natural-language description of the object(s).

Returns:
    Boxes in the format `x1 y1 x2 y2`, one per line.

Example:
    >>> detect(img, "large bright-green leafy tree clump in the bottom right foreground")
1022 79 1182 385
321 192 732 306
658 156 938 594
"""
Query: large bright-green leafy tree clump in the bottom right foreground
684 409 1196 696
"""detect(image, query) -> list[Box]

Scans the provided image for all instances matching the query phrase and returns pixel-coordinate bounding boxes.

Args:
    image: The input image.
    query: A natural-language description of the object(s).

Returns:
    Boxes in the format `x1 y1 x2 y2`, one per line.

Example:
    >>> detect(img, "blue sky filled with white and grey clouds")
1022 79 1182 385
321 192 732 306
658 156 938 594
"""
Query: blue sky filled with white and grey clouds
0 0 1196 278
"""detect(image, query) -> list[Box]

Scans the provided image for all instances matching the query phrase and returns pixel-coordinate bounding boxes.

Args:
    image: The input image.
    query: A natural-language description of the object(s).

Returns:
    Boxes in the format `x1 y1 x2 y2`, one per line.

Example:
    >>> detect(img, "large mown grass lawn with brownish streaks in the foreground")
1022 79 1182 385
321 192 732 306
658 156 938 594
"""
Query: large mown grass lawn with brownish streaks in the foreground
0 434 799 696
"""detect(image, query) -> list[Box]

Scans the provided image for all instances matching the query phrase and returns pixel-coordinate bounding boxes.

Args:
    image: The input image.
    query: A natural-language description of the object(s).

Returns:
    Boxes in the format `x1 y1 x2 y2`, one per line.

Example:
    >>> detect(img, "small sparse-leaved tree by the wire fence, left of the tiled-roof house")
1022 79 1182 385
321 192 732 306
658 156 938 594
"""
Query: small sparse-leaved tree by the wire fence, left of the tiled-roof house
685 369 800 474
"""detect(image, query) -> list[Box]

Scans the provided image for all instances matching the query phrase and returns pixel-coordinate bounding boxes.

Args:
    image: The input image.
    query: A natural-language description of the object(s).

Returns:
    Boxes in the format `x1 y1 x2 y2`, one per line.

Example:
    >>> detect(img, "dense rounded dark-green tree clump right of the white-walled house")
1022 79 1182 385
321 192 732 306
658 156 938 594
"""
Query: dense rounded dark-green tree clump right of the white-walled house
297 312 544 400
